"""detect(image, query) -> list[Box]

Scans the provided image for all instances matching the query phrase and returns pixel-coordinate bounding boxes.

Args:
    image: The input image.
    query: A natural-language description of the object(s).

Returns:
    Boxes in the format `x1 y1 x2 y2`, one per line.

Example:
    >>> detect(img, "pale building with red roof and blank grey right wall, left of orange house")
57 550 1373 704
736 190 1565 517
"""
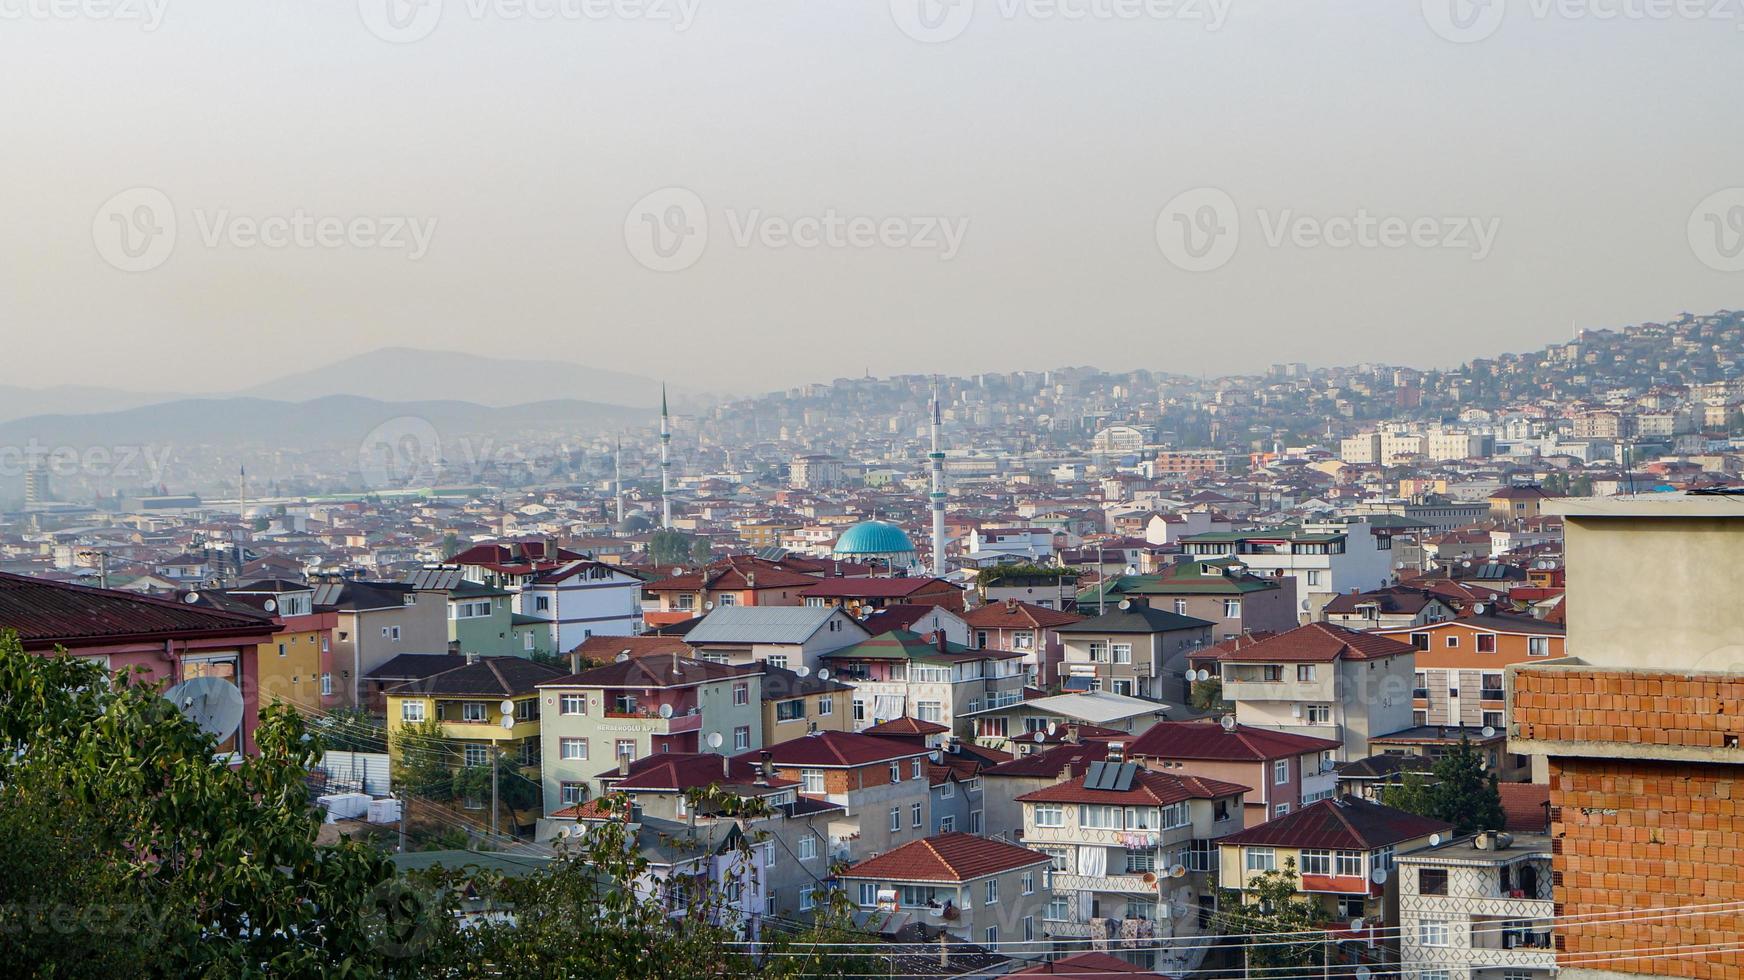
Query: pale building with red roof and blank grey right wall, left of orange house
1217 623 1416 762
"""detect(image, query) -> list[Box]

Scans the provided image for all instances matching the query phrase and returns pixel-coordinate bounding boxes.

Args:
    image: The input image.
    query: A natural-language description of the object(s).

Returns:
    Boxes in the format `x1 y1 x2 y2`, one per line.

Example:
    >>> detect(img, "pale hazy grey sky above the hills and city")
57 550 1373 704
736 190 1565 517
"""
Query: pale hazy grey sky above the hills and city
0 0 1744 398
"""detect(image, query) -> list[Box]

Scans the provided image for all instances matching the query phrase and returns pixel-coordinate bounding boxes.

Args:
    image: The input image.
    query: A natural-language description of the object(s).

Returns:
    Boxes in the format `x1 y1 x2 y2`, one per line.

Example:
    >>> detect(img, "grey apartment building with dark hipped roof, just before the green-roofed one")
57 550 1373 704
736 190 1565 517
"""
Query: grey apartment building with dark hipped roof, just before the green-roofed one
1057 600 1212 699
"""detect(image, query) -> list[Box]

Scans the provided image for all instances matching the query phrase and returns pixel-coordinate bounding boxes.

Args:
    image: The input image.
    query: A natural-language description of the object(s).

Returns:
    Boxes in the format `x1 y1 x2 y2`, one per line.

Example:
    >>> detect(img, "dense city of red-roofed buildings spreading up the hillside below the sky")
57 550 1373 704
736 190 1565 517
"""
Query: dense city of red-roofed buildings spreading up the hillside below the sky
0 312 1744 980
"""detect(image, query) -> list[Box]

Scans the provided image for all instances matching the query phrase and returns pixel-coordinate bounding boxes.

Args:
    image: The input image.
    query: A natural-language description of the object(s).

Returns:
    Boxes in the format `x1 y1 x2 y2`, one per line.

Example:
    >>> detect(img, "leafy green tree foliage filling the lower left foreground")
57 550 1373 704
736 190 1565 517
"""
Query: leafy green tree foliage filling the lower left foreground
0 633 888 980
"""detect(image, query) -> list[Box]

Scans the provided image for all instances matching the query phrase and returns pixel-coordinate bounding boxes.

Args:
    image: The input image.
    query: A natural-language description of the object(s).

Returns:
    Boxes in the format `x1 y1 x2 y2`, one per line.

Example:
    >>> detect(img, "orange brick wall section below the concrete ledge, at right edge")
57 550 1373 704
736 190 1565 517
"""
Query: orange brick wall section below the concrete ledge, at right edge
1550 757 1744 980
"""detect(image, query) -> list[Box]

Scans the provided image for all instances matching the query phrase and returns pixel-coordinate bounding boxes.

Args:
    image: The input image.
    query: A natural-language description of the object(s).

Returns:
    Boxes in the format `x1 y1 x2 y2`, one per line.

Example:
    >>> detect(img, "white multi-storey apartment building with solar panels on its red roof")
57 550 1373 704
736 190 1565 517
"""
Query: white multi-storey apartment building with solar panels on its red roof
1017 759 1247 973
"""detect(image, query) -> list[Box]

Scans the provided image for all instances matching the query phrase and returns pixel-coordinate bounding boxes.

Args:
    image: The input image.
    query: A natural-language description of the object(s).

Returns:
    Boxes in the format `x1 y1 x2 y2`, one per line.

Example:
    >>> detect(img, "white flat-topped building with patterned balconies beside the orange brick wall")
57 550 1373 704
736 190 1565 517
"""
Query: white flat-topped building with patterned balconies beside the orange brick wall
1395 832 1556 980
